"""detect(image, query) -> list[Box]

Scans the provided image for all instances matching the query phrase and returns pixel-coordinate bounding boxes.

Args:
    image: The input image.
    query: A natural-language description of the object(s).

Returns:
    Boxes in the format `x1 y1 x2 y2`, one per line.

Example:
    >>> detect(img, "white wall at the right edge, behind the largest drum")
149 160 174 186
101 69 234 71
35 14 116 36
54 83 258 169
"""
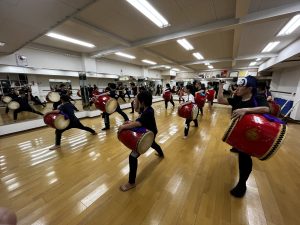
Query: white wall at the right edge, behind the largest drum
270 66 300 120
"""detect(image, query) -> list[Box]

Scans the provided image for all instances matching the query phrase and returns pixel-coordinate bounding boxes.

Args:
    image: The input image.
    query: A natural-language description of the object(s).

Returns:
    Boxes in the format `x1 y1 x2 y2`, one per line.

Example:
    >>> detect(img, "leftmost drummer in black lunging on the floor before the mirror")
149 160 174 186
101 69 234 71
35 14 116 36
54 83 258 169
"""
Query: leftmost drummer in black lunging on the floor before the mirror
49 95 97 150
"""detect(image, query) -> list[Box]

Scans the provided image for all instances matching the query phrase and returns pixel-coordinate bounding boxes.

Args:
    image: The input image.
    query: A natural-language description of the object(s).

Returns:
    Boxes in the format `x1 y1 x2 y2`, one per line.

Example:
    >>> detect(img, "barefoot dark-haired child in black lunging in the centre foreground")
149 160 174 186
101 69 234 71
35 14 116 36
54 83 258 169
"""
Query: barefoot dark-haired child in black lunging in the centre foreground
119 91 164 191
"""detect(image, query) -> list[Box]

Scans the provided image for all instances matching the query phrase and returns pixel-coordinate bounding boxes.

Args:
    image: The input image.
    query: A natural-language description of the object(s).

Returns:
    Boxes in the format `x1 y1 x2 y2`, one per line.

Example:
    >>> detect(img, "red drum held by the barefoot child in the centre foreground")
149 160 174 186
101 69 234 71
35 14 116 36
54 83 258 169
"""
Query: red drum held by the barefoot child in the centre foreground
118 127 154 154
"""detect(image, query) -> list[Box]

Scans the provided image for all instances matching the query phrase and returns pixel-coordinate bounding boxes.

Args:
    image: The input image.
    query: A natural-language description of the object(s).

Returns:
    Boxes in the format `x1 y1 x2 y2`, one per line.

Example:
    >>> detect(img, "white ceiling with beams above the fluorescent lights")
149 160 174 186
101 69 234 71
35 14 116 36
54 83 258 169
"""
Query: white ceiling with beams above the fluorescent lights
0 0 300 71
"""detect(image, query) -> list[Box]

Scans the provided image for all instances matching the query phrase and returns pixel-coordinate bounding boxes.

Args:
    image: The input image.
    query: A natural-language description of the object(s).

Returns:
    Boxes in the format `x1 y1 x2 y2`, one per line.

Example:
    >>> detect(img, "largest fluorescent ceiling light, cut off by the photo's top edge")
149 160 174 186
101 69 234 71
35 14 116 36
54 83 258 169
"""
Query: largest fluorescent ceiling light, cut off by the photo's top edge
127 0 170 28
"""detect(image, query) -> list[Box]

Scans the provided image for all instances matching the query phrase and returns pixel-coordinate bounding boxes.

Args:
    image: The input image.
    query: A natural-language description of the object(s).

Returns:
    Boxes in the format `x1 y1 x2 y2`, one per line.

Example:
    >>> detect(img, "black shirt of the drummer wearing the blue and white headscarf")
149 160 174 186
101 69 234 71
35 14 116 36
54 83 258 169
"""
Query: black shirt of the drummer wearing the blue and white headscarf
227 96 269 110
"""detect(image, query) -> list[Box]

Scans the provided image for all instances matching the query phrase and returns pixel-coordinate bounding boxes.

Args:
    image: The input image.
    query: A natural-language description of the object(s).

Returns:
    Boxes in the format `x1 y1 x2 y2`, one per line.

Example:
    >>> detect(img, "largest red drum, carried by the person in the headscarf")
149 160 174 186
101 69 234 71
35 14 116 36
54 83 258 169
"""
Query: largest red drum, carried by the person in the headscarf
223 114 287 160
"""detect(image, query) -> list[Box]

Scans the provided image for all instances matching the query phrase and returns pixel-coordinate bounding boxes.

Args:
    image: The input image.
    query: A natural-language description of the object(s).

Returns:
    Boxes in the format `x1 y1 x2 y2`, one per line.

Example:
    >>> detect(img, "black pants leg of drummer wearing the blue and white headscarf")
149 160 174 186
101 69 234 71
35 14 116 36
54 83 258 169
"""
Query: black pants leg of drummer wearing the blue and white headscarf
236 149 252 186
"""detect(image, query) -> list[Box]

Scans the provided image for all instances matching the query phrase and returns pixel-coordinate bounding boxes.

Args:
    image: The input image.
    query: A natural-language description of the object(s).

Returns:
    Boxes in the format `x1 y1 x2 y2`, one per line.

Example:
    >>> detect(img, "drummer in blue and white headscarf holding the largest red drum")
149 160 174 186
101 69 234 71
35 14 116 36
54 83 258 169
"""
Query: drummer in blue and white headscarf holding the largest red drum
218 76 270 198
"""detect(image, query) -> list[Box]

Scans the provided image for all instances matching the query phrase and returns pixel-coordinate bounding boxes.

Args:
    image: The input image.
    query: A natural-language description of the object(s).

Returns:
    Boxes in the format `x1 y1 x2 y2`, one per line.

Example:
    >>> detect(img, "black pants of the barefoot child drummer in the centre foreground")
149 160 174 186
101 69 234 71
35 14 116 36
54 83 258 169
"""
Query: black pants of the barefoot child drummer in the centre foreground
128 138 164 184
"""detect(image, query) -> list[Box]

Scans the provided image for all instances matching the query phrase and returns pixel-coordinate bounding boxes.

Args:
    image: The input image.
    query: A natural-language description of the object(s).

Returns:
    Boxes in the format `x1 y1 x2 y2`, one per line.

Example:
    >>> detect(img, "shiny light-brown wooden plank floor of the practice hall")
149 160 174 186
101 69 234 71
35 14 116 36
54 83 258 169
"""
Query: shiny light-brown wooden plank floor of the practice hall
0 103 300 225
